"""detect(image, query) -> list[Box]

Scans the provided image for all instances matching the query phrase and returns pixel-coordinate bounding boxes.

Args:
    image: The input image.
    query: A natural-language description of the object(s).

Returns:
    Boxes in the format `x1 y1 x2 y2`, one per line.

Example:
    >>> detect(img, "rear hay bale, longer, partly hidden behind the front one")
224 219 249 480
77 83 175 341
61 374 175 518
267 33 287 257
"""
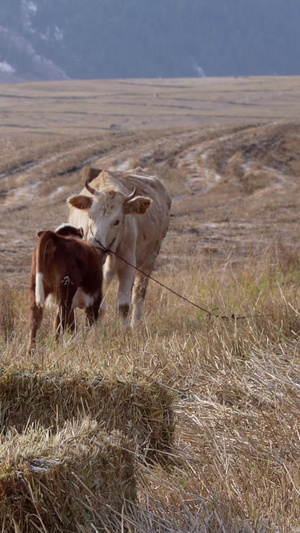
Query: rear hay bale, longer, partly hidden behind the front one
0 371 175 459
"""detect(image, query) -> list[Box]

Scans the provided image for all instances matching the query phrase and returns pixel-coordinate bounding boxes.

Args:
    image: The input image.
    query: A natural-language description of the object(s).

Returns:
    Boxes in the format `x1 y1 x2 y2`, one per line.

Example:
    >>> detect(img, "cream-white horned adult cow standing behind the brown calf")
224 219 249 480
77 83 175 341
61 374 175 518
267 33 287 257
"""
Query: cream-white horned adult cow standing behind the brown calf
67 168 171 327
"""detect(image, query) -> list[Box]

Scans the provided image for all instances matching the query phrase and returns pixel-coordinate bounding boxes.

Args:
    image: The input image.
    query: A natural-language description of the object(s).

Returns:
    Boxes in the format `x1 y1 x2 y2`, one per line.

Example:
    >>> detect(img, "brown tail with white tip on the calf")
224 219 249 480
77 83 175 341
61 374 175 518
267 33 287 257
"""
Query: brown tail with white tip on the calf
35 231 55 307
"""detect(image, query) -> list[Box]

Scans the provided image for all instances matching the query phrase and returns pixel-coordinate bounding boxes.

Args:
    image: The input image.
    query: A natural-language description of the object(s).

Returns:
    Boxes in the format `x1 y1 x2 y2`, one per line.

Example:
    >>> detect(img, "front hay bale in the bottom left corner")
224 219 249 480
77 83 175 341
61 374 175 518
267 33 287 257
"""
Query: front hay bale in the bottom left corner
0 422 136 533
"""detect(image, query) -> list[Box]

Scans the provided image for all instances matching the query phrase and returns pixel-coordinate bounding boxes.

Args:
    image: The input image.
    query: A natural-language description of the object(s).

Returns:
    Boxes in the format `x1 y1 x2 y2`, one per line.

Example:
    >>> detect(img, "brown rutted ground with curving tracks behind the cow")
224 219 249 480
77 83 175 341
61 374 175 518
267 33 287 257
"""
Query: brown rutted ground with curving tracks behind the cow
0 122 300 284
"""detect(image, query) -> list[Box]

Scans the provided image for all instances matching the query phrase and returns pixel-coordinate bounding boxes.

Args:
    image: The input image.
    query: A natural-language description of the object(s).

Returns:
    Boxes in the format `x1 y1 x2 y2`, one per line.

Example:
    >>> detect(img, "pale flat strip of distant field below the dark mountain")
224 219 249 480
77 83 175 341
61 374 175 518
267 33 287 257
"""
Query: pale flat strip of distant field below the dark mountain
0 76 300 136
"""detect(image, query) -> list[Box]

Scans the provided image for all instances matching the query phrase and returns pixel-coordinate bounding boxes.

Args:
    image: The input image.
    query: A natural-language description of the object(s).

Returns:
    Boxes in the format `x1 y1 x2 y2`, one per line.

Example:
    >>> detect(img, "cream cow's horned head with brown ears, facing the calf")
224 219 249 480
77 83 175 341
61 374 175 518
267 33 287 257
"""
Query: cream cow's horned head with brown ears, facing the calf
68 181 152 250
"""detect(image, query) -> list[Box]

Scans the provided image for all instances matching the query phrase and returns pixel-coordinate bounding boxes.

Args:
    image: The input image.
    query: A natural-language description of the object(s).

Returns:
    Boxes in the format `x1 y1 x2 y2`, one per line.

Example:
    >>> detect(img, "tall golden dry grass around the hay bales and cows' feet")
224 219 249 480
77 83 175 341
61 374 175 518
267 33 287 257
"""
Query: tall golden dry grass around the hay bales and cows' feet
0 250 300 533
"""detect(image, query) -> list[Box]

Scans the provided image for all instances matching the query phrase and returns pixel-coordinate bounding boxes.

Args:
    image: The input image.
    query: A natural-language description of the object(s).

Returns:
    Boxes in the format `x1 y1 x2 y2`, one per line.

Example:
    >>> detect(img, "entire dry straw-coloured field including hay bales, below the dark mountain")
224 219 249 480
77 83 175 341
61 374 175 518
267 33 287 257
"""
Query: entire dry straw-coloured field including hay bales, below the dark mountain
0 77 300 533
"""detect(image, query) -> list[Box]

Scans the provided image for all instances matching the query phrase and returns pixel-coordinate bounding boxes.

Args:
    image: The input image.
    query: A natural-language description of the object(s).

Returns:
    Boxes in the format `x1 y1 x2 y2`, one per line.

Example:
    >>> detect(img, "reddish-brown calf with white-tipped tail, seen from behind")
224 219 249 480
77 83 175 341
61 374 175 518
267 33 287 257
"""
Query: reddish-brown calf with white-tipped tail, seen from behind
28 224 104 352
